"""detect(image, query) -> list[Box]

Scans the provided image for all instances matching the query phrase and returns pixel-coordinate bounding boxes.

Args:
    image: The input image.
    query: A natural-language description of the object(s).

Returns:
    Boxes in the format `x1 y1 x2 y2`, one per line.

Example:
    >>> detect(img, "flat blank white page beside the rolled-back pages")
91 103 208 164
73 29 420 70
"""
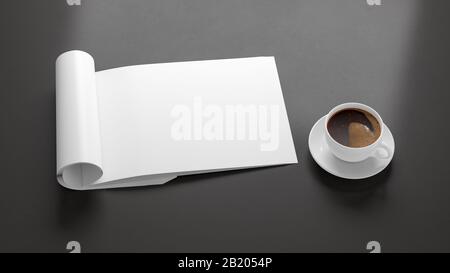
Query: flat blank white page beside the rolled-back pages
56 50 297 189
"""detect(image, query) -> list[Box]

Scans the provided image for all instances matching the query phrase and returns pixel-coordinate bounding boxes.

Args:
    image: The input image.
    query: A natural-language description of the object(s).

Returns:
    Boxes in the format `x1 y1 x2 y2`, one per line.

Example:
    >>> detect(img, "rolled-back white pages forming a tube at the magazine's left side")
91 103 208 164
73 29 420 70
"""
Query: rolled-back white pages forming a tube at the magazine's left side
56 51 103 189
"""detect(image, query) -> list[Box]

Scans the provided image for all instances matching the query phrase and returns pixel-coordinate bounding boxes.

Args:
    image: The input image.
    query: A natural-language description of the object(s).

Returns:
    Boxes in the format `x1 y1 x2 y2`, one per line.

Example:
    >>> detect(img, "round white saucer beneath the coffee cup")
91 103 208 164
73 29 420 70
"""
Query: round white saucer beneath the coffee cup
308 117 395 179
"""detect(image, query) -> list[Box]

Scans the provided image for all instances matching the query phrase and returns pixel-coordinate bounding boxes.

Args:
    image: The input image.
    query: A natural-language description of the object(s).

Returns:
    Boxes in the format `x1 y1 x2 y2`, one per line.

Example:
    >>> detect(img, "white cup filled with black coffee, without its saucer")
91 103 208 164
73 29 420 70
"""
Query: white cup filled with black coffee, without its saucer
325 102 392 162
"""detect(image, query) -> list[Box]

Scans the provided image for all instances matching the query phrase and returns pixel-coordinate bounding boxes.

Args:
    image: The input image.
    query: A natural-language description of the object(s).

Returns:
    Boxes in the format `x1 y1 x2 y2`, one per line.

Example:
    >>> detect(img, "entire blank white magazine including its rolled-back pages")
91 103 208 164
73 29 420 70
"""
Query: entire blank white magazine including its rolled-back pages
56 51 297 190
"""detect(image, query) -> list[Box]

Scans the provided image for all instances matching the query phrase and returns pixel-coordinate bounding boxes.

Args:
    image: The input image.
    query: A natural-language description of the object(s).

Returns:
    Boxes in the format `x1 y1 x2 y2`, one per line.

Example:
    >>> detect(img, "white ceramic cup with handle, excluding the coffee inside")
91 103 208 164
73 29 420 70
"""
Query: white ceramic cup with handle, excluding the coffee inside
325 102 392 162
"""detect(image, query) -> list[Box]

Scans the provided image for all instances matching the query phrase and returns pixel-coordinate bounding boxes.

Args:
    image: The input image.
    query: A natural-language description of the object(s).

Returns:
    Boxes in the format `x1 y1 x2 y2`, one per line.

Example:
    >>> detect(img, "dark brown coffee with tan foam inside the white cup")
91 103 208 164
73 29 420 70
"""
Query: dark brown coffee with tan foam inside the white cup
327 108 381 148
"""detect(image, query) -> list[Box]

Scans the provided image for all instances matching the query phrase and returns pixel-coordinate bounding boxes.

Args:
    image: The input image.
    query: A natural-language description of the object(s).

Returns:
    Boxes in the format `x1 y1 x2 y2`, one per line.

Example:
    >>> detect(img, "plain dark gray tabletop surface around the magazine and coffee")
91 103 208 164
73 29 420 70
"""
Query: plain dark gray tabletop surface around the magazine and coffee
0 0 450 252
